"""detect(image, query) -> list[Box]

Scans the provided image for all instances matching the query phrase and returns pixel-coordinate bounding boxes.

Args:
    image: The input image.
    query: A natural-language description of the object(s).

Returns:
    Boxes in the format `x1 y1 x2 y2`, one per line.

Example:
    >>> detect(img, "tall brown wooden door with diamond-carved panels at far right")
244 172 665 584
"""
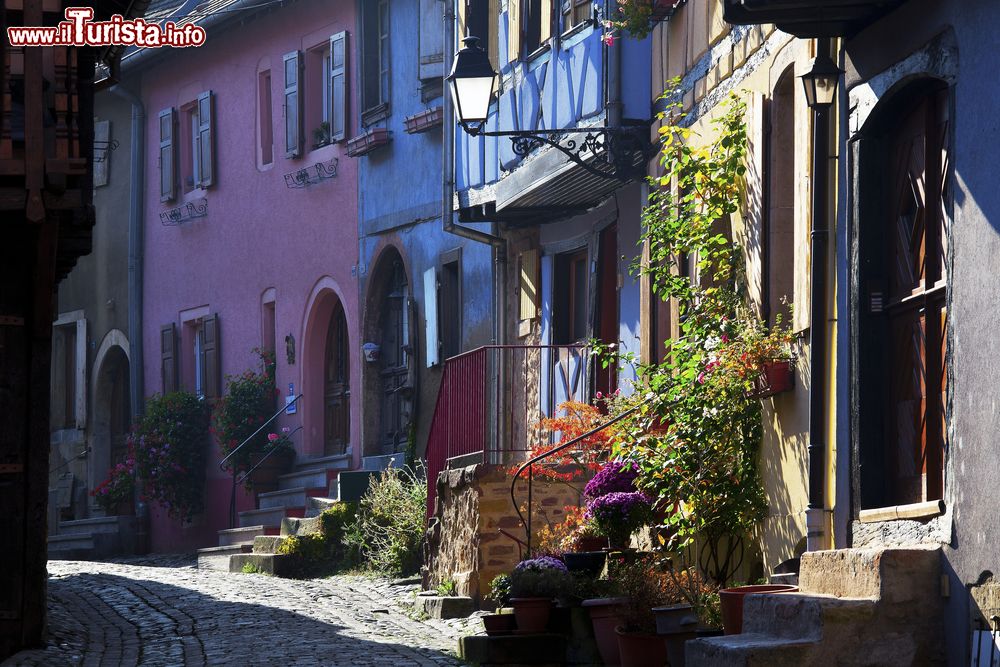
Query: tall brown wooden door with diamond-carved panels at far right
883 91 948 504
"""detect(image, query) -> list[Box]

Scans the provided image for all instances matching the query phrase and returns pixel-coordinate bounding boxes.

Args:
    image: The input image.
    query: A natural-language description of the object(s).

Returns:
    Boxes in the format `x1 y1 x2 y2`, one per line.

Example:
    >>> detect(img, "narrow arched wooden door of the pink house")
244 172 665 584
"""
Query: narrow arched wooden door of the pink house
323 303 351 456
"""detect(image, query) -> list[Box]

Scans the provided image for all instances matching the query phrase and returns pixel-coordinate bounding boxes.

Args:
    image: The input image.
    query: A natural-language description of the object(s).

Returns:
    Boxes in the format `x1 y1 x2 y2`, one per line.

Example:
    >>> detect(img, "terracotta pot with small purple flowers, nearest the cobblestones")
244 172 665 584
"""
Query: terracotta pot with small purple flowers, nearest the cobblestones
510 556 572 634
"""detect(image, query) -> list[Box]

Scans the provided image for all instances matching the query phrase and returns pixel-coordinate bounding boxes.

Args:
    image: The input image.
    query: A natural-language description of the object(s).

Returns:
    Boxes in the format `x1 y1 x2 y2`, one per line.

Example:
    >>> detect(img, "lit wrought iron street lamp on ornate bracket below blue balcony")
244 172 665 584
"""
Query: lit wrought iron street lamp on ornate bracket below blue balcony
447 36 653 181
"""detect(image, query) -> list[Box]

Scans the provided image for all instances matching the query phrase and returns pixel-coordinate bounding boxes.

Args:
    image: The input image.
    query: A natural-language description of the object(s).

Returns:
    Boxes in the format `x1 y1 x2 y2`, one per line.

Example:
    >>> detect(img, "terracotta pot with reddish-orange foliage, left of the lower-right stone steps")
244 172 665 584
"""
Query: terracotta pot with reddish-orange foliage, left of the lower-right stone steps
614 557 676 667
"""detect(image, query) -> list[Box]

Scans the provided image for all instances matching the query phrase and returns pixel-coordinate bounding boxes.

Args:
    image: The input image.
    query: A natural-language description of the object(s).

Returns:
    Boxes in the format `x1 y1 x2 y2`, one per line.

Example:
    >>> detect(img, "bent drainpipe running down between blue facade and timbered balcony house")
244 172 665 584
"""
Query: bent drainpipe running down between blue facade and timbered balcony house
441 0 507 460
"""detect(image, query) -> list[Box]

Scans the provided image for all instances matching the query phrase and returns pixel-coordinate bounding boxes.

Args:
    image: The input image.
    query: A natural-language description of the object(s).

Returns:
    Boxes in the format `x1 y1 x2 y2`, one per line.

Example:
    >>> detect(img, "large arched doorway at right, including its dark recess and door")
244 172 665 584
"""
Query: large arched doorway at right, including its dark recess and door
855 80 950 508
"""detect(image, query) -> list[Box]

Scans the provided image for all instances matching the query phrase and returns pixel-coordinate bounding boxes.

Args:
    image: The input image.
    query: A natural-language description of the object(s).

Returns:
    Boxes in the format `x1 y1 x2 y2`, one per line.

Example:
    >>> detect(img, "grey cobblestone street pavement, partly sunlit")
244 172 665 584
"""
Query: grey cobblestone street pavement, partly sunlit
0 557 482 667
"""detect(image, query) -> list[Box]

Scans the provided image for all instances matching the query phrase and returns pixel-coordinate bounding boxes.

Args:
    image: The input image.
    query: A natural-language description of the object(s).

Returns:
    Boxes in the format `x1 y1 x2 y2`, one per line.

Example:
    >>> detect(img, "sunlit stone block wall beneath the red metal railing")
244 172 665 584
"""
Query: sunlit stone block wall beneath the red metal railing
423 464 587 602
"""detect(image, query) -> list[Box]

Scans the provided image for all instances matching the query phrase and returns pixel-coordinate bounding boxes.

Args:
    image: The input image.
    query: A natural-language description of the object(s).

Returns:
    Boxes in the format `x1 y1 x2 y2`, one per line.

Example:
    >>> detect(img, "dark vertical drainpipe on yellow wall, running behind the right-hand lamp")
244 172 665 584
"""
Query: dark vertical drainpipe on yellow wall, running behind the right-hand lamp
806 38 832 551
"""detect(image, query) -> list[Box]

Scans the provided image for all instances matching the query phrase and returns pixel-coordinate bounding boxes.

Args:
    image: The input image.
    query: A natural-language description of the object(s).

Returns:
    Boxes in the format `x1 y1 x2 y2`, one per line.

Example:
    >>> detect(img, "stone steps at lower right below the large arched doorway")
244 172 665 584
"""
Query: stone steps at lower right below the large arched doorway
685 547 945 667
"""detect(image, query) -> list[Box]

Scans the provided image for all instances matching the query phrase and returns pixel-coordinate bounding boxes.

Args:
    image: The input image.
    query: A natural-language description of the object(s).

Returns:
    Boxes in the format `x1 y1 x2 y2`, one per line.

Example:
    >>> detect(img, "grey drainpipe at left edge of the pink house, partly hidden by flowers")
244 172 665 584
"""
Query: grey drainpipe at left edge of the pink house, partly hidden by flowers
108 84 149 554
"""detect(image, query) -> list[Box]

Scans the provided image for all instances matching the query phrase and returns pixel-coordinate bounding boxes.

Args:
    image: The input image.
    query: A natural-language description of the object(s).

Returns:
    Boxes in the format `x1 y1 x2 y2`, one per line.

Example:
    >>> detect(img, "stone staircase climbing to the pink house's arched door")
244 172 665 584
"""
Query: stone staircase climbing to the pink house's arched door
198 455 351 571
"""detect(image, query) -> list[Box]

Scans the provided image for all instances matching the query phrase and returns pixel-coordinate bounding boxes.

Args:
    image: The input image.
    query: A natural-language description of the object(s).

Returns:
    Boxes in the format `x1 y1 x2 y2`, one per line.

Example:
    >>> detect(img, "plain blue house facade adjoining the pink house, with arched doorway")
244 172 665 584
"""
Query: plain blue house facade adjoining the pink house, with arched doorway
348 0 494 463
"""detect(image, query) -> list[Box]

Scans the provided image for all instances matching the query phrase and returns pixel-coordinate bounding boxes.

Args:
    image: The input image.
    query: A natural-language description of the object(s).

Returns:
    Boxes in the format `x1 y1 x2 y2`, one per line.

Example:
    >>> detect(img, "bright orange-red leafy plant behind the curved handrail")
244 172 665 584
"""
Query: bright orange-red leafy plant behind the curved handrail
510 401 618 482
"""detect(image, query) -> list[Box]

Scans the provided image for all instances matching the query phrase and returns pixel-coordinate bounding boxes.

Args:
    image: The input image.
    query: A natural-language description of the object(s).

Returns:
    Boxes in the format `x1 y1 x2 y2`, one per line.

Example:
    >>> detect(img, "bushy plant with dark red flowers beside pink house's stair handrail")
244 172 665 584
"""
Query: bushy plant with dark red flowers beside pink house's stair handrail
212 349 292 484
